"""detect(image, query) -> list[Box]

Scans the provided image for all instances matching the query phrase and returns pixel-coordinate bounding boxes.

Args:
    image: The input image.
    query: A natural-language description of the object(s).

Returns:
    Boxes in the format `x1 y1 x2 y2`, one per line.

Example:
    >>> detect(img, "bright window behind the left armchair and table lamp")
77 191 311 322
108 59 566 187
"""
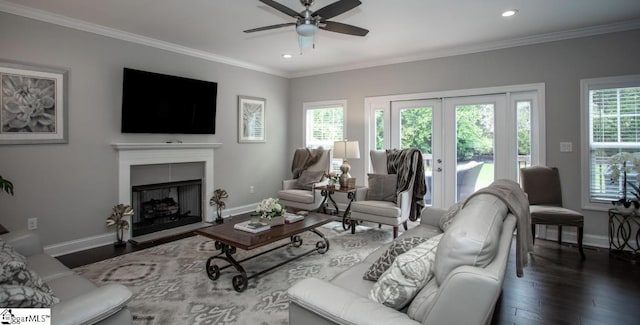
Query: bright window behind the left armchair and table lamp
303 100 347 171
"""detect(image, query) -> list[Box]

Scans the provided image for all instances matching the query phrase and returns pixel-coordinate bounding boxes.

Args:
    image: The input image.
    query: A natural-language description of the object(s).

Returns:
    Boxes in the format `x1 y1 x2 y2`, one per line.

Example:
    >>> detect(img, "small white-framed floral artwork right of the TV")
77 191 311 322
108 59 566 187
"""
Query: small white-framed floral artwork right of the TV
238 96 267 143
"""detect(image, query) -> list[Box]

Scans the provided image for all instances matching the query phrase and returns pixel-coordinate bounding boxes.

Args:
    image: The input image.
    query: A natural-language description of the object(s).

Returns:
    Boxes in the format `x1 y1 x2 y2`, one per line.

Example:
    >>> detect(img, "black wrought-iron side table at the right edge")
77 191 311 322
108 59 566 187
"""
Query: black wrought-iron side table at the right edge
609 209 640 264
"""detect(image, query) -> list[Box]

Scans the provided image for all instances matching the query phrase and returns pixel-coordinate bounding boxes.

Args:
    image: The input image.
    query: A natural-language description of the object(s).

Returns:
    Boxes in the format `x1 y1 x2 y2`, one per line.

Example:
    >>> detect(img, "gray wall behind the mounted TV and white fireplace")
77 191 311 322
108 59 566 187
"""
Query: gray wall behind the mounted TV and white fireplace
0 13 291 245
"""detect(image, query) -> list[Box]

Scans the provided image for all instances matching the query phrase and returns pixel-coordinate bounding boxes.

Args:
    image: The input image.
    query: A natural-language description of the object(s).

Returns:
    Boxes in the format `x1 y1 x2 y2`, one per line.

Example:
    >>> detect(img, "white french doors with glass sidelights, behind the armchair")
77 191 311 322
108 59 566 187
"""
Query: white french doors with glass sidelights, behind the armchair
370 88 539 207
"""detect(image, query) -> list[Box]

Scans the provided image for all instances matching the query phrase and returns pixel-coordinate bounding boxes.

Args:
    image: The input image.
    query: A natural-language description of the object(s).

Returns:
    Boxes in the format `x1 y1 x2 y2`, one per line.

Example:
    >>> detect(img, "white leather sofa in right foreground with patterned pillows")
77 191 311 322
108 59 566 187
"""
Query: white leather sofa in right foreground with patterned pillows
288 190 516 325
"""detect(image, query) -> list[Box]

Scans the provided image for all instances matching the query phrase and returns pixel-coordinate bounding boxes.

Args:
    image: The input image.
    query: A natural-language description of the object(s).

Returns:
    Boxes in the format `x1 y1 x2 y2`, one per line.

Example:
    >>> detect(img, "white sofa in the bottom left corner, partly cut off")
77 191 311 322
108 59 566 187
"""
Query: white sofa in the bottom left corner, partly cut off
0 231 132 325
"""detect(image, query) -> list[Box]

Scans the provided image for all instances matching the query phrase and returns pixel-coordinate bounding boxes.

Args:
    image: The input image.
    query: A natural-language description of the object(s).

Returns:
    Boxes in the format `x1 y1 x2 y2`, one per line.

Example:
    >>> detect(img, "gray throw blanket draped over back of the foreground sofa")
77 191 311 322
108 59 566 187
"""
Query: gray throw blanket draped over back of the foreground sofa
465 179 533 277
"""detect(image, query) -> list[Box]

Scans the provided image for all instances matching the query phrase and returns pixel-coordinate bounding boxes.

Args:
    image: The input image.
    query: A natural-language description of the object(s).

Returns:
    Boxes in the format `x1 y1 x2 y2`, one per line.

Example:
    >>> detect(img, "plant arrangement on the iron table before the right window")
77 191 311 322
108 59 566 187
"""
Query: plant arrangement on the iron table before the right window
609 152 640 209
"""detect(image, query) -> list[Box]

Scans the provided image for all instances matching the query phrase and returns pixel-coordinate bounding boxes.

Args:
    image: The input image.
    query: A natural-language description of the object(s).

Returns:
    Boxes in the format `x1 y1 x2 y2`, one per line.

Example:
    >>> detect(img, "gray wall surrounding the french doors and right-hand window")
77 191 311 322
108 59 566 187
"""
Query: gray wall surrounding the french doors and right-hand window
289 30 640 239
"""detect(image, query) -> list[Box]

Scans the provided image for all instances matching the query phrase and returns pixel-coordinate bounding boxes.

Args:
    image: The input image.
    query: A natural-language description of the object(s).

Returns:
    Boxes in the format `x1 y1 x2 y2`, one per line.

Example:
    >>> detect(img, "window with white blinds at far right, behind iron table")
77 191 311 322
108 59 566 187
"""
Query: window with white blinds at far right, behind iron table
581 75 640 205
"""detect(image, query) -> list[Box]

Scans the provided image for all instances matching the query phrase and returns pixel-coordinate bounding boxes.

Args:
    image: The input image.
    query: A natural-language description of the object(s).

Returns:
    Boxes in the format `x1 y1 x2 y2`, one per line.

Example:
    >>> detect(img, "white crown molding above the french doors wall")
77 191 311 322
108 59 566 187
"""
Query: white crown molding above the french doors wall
288 19 640 79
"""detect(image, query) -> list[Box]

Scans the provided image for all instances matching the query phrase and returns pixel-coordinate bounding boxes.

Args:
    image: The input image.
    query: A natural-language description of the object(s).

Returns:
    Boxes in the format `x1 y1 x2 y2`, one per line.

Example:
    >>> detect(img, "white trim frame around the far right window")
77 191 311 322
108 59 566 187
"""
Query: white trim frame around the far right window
580 74 640 211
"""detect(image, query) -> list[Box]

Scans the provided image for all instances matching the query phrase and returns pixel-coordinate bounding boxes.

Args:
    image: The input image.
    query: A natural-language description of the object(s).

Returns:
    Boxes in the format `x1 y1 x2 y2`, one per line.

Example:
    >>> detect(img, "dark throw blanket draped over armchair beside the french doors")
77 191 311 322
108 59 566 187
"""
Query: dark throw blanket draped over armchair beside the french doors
387 148 427 221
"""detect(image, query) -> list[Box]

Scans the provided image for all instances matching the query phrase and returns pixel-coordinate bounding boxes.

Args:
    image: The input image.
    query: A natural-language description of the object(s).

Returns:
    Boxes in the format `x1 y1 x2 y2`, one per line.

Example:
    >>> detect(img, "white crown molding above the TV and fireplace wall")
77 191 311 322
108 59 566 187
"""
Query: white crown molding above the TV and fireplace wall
0 0 288 77
